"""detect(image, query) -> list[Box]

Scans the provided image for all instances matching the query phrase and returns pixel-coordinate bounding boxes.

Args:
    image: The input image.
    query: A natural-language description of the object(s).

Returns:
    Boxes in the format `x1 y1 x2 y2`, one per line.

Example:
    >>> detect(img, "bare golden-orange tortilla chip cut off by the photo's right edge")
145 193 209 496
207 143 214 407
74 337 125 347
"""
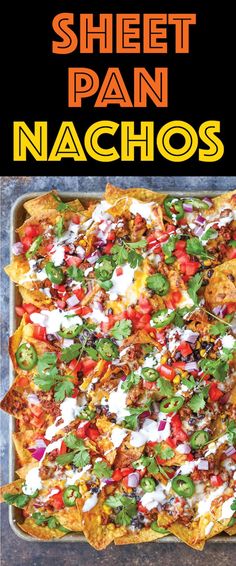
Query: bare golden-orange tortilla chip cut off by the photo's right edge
205 259 236 308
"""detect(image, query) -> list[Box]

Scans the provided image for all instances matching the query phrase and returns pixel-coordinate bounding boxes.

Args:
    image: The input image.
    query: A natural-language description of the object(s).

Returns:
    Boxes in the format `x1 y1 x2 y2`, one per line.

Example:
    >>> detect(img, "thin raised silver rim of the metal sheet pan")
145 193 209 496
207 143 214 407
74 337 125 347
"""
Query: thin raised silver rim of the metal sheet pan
9 189 236 544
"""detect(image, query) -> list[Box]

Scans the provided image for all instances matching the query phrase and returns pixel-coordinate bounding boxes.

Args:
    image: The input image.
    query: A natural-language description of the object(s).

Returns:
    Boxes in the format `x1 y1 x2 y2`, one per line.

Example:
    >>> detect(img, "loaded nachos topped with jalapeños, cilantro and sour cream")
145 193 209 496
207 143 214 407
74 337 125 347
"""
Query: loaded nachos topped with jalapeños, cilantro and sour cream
1 185 236 549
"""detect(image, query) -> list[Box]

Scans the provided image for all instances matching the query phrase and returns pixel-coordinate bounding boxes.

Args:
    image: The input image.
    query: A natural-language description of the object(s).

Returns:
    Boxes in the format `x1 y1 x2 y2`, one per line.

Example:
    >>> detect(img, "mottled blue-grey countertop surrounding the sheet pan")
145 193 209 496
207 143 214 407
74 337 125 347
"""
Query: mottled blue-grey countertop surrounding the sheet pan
0 177 236 566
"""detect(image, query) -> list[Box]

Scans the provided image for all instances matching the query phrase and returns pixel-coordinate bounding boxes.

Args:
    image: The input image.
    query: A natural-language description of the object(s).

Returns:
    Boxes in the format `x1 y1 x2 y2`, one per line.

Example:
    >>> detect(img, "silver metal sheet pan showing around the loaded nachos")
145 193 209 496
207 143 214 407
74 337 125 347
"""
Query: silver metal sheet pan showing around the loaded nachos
9 191 236 544
